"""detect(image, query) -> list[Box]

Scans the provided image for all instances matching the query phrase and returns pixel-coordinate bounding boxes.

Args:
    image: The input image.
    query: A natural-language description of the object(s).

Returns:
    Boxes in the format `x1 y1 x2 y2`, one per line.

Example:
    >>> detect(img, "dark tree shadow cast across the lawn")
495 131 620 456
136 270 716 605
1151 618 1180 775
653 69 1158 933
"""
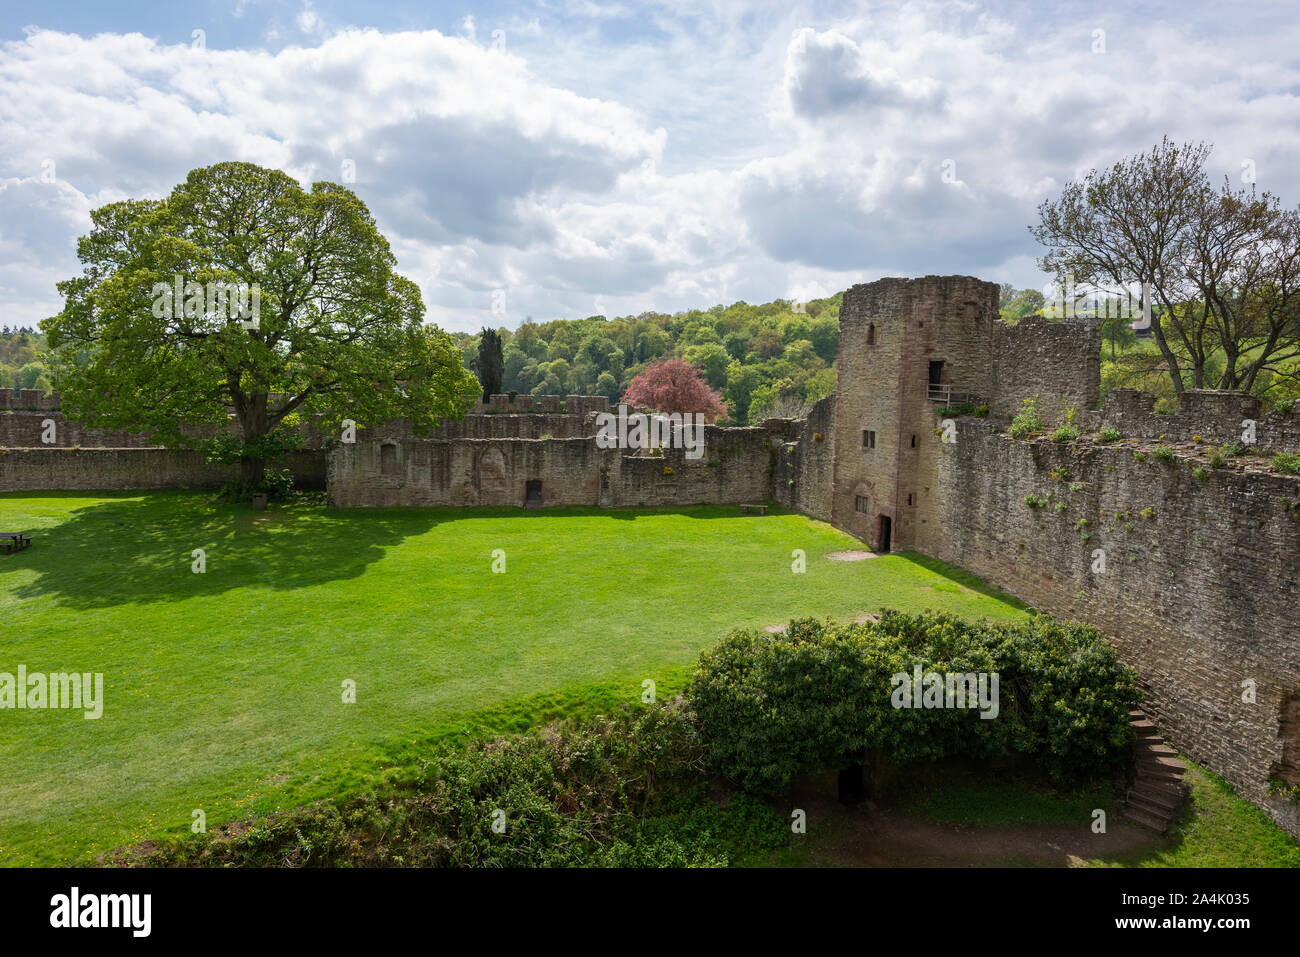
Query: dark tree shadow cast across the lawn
0 493 441 609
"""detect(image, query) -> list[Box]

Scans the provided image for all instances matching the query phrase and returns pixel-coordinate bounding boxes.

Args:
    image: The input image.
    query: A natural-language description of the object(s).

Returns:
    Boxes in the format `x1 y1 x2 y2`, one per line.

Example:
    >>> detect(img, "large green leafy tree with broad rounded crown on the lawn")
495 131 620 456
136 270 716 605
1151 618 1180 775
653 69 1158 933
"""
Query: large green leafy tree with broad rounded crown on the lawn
42 163 478 481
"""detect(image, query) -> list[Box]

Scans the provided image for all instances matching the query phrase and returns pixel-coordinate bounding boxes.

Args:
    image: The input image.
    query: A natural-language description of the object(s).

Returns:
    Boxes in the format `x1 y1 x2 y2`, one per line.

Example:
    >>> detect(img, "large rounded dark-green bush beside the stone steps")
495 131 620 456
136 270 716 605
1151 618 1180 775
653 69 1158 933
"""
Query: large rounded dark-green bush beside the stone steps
686 611 1138 793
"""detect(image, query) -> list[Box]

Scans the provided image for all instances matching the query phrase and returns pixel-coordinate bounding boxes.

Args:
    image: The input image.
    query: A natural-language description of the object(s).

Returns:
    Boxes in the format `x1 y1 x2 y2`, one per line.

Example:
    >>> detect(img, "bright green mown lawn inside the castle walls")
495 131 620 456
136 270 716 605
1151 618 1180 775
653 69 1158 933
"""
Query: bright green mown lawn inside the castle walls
0 493 1023 865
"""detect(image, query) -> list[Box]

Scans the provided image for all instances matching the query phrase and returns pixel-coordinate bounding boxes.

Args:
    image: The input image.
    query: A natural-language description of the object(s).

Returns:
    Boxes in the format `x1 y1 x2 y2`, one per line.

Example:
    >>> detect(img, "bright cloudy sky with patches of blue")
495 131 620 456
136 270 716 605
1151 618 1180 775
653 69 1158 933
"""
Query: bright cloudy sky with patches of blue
0 0 1300 330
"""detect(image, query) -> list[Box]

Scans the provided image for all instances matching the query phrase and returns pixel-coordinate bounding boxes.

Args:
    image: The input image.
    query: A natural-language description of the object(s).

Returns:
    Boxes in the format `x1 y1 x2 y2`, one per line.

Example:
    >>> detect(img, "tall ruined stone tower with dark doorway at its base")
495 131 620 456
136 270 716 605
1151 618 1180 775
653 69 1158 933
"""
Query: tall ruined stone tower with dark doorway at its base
831 276 998 554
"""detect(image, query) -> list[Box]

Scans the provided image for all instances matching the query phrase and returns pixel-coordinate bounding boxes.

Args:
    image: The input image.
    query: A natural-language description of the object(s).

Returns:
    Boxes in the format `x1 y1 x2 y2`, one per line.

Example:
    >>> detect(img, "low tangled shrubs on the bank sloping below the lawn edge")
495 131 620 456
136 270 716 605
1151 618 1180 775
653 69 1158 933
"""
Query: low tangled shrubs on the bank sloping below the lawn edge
109 700 789 867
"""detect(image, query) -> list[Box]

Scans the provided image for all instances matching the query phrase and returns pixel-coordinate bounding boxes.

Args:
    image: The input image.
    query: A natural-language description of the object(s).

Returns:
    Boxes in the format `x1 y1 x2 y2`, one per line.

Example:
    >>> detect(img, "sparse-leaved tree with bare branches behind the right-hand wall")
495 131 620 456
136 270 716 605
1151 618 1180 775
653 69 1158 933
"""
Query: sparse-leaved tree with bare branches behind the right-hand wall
1031 137 1300 393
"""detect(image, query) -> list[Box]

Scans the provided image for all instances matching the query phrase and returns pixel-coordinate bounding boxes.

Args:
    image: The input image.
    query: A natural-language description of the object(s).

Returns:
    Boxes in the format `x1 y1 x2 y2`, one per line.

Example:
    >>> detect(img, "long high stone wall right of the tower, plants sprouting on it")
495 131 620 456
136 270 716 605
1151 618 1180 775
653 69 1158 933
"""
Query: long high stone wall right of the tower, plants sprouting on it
927 419 1300 836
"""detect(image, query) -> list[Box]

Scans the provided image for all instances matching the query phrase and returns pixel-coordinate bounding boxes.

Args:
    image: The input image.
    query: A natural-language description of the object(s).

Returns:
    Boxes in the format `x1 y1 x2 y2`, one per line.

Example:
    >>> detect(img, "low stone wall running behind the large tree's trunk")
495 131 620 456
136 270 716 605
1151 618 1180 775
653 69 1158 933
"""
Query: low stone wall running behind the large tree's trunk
0 447 325 492
